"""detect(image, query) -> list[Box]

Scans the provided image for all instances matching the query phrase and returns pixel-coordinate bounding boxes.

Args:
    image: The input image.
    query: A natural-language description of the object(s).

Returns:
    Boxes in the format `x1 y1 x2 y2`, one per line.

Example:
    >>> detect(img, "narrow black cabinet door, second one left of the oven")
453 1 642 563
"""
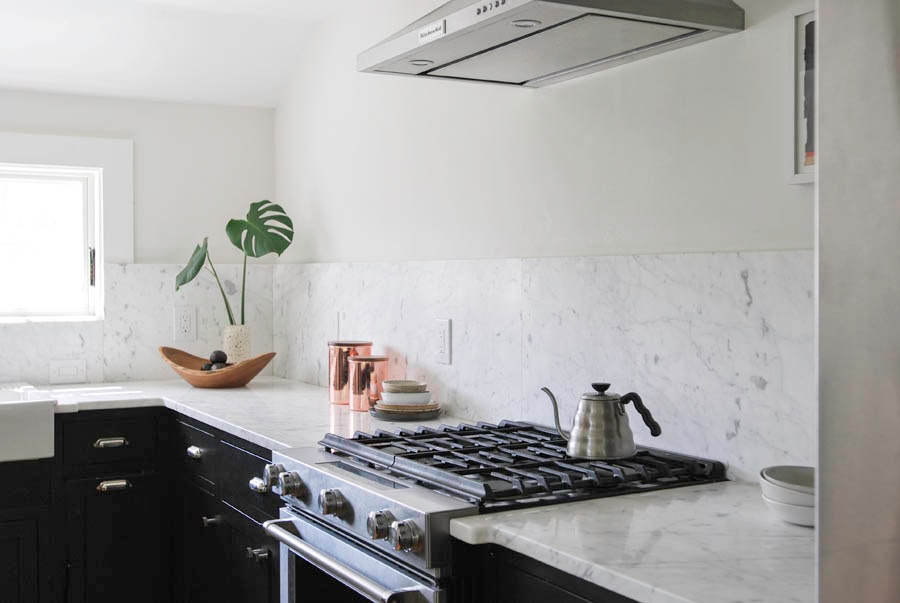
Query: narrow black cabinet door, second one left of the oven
174 484 229 603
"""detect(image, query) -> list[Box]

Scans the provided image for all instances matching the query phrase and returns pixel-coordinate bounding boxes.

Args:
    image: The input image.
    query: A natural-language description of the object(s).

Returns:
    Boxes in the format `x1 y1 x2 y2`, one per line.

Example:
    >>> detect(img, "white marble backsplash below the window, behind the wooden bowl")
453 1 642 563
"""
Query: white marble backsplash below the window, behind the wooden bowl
0 264 273 384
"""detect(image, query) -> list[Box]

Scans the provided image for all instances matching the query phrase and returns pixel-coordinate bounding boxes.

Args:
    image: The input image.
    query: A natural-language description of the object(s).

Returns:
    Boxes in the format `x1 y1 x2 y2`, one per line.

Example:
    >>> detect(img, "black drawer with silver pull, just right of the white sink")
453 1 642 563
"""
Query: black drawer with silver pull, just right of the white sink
63 411 158 467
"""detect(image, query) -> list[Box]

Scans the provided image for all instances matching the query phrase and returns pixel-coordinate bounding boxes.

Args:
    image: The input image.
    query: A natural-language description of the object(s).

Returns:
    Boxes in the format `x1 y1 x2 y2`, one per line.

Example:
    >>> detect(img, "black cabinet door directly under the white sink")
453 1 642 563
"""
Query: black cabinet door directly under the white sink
0 512 40 603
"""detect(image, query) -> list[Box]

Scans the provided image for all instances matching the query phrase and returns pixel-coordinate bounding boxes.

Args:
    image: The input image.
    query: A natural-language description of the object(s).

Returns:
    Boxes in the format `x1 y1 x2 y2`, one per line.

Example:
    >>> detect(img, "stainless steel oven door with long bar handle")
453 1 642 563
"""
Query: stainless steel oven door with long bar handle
263 508 447 603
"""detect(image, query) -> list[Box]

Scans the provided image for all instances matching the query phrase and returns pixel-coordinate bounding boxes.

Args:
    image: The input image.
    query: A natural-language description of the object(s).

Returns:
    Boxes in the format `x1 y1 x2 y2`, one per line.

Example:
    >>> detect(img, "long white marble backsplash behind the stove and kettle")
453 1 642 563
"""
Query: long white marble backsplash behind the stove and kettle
274 251 816 480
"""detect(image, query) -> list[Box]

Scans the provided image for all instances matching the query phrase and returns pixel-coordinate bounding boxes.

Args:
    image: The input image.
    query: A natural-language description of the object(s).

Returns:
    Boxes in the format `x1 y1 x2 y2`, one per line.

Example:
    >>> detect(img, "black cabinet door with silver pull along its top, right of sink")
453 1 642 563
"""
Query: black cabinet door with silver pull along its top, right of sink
66 473 171 603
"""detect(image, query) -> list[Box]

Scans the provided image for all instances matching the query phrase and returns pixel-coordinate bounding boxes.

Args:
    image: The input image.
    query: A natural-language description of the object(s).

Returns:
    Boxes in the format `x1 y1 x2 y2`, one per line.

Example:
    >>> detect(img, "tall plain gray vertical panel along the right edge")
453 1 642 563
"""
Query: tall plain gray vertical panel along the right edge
819 0 900 603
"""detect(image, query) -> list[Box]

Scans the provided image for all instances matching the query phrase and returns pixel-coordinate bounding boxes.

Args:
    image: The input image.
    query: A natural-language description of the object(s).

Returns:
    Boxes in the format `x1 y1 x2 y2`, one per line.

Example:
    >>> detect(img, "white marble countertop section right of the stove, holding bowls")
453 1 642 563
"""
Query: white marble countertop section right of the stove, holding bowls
450 482 815 603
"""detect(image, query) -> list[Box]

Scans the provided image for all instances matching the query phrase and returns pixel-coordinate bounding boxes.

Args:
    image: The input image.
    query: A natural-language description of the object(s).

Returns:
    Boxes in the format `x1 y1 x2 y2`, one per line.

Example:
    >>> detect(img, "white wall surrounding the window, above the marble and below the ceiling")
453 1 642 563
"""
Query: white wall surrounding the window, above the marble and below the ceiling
0 90 274 263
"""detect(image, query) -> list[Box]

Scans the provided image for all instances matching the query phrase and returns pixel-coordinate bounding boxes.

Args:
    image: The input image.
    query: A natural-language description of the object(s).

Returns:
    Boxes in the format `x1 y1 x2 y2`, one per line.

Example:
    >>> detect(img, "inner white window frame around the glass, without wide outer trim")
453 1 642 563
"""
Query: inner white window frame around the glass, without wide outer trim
0 163 103 322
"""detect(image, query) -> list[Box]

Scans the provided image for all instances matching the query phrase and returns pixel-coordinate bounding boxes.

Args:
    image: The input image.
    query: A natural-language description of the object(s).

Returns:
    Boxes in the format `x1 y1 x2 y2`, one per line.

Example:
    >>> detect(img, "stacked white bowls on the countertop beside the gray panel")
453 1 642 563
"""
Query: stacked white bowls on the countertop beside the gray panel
759 465 816 527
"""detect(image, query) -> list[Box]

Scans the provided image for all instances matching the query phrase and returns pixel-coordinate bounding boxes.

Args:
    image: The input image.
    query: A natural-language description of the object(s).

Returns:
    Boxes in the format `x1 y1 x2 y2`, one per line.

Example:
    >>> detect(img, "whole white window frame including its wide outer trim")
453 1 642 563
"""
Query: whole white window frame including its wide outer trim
0 132 134 323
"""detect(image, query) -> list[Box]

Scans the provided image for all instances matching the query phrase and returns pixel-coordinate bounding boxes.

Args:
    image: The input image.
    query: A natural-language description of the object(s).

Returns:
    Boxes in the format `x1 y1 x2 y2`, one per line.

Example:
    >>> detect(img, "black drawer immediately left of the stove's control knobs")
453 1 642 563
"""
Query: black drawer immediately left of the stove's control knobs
219 442 281 522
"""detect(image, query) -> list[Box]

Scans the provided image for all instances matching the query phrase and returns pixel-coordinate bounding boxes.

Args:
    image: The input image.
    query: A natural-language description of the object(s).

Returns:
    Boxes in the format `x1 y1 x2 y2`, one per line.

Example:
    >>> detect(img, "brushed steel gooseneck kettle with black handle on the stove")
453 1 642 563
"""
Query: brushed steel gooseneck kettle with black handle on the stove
541 383 662 460
